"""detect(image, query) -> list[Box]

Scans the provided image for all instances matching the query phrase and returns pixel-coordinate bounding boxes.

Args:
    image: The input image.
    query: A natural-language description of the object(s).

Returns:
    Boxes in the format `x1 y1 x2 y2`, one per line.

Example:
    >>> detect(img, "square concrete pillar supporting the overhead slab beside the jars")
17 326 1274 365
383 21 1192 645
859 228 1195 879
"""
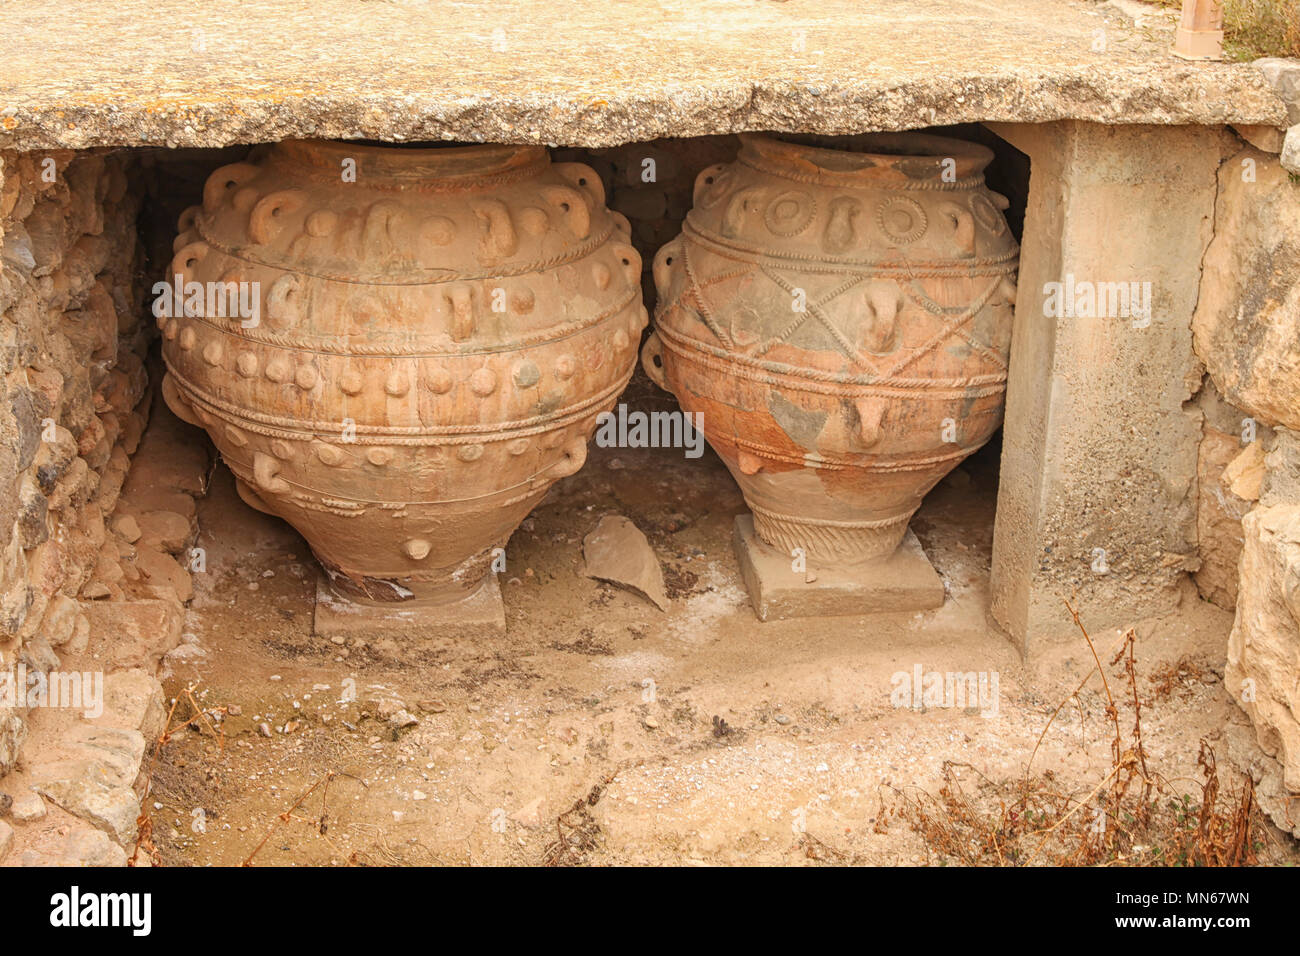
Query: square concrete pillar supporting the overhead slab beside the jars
989 122 1222 652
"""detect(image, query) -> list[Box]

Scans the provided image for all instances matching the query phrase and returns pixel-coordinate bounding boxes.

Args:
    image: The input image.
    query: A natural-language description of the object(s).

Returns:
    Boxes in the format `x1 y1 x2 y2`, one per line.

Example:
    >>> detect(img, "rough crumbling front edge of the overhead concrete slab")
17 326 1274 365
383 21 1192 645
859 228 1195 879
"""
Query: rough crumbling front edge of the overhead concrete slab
0 65 1287 150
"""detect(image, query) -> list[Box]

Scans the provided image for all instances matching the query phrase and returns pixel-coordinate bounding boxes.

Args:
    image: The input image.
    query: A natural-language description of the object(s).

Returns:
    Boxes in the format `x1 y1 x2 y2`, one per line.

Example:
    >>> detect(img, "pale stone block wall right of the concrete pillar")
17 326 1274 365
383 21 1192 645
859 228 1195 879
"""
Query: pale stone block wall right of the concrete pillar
1192 147 1300 825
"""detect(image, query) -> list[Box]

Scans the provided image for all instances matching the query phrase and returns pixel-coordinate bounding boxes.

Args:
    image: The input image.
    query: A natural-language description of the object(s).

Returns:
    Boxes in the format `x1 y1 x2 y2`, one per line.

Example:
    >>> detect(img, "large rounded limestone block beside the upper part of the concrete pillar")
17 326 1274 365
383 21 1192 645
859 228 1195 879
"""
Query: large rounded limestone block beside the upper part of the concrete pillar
1192 150 1300 429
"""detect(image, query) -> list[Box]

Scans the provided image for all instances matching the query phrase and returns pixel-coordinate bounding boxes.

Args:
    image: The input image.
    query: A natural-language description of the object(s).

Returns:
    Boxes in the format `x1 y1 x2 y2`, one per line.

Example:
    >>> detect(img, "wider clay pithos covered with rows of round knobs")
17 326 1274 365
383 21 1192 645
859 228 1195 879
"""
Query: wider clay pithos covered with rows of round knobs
160 140 647 604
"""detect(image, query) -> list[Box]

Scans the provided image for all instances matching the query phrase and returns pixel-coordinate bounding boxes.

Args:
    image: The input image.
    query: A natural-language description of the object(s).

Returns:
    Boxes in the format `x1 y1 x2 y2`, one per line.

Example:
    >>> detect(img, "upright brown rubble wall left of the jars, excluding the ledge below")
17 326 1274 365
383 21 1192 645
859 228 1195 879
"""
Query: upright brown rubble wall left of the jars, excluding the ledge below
0 150 148 777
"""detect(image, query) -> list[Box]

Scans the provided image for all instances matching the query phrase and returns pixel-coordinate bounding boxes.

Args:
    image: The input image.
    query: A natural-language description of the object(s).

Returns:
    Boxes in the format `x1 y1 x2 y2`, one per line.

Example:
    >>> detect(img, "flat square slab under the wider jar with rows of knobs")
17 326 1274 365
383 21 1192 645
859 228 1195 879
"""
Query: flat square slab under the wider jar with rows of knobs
315 574 506 640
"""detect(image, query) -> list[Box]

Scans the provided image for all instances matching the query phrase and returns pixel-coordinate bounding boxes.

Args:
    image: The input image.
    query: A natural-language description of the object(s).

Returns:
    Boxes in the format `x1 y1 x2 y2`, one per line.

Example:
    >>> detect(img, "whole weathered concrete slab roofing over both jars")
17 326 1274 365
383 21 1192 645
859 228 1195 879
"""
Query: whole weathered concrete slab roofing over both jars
0 0 1287 150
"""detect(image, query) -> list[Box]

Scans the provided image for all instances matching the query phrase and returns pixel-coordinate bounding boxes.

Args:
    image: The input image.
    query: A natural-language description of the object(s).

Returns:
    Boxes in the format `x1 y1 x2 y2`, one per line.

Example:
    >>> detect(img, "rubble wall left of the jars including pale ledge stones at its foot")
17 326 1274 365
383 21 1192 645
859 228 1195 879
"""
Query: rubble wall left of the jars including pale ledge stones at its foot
0 151 209 865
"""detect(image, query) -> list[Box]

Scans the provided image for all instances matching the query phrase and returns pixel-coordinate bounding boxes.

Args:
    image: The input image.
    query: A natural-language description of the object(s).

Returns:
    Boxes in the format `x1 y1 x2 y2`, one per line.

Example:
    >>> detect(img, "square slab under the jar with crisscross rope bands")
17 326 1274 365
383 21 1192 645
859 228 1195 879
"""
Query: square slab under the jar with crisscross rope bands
732 515 944 620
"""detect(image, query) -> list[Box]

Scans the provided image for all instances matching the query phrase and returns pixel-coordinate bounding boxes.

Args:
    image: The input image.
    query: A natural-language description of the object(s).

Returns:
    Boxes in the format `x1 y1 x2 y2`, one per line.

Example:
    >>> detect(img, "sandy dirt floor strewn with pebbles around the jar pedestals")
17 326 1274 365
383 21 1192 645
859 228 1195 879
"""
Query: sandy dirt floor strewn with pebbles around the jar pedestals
134 384 1300 865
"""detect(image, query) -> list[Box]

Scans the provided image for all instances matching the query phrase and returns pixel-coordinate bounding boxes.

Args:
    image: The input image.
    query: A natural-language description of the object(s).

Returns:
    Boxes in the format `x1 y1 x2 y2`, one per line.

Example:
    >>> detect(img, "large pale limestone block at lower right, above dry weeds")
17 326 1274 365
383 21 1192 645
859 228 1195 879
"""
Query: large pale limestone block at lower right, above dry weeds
1223 505 1300 795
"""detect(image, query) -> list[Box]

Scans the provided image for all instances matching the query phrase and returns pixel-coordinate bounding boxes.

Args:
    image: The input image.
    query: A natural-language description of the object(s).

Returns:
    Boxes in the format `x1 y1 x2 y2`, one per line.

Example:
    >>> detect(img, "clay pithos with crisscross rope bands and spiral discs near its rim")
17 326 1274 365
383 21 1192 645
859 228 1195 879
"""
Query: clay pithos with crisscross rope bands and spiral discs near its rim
642 134 1018 562
